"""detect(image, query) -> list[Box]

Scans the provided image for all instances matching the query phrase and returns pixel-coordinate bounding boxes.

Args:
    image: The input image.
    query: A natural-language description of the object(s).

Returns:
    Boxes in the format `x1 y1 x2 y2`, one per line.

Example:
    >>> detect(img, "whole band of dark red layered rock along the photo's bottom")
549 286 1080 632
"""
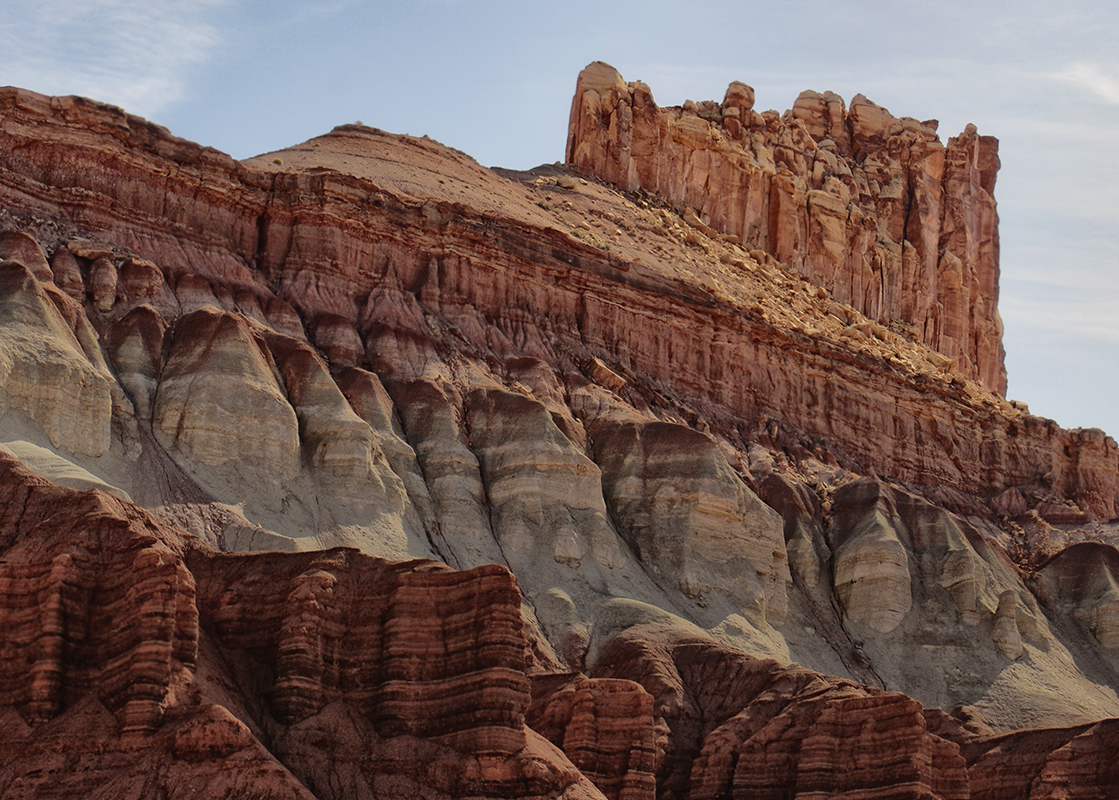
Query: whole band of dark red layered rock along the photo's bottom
0 453 1119 800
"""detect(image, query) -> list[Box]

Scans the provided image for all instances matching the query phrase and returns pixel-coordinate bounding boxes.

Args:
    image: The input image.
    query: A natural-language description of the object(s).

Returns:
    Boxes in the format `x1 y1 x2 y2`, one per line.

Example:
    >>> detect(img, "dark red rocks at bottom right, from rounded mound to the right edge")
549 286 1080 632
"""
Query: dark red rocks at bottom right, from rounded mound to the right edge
595 629 1119 800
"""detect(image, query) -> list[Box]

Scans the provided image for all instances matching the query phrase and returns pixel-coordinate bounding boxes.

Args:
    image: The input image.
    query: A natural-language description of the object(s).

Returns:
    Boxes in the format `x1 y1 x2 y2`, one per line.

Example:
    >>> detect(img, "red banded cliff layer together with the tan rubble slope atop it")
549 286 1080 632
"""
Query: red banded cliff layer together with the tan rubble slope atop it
0 90 1119 519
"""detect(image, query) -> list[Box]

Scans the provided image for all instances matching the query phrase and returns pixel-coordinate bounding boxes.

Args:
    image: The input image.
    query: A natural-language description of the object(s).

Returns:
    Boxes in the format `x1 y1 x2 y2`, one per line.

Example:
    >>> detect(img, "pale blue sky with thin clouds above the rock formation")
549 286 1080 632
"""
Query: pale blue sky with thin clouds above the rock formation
0 0 1119 437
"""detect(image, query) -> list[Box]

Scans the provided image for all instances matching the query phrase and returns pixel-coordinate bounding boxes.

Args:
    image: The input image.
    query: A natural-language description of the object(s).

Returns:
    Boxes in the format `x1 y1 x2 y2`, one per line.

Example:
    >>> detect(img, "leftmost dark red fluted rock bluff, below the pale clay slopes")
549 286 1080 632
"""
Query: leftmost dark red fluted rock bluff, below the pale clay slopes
0 457 198 734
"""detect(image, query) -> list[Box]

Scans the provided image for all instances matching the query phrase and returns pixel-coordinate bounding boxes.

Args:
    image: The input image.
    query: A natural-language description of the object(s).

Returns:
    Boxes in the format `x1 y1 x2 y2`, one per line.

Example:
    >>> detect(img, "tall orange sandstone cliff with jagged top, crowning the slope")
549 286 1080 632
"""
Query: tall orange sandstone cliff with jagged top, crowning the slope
567 62 1006 394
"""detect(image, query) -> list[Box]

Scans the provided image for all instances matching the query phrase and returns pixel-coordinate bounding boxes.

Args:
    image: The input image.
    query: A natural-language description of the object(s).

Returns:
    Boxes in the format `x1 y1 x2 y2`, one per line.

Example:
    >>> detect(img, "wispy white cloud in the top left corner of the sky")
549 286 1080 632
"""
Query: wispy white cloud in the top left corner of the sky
0 0 224 115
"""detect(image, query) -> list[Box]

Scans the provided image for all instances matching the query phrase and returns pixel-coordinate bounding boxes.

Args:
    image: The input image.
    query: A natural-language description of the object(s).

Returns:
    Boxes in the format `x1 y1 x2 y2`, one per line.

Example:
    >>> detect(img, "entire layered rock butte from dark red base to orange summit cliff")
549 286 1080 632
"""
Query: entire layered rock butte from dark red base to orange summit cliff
0 64 1119 800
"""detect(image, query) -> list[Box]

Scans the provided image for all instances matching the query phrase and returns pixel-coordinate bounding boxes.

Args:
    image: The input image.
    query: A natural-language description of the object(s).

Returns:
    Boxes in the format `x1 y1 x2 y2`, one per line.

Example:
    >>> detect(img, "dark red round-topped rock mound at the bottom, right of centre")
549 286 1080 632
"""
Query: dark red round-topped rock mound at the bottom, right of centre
595 631 968 800
